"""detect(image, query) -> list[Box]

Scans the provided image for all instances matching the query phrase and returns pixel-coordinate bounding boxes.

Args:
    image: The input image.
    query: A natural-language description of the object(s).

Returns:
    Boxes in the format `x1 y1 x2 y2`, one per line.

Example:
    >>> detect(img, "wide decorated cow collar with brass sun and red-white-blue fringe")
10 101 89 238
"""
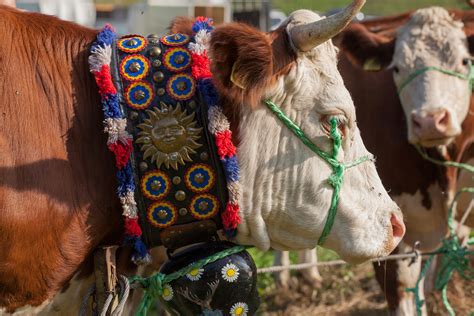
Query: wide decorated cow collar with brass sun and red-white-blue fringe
89 18 240 264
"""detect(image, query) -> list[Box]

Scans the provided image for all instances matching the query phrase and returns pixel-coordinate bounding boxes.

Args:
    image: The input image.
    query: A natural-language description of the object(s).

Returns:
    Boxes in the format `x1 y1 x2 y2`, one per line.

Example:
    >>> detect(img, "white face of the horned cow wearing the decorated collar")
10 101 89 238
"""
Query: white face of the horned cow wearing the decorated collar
237 11 404 262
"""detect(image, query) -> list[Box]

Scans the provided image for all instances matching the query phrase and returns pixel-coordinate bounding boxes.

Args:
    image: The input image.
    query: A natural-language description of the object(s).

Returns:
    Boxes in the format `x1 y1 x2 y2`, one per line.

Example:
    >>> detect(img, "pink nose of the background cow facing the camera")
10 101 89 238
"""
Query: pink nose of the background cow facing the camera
411 110 451 140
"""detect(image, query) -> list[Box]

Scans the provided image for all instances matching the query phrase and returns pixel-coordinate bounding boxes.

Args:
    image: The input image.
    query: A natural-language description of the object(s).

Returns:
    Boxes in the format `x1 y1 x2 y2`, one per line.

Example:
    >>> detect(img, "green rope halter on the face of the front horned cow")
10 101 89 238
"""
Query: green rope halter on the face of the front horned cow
265 100 373 246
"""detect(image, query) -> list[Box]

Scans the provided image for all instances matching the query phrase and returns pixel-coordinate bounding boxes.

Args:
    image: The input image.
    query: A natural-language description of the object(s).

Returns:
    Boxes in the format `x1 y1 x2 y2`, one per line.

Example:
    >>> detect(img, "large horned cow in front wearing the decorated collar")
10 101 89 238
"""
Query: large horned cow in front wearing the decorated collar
0 0 405 314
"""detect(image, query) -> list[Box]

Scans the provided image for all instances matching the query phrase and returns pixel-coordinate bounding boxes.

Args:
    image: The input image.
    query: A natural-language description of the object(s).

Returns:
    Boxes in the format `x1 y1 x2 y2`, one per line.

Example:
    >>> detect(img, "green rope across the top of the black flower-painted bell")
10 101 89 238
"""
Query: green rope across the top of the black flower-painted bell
129 246 249 316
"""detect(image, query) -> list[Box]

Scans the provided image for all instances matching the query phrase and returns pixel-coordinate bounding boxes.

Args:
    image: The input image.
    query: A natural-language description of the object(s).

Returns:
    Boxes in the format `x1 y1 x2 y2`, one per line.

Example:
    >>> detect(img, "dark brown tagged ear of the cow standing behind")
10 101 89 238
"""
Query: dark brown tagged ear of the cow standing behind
339 23 395 71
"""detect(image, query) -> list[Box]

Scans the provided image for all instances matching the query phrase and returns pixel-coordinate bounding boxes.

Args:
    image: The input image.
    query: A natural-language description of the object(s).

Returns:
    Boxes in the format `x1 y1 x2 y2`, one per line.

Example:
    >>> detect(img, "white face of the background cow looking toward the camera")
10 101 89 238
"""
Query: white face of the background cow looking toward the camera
392 7 471 147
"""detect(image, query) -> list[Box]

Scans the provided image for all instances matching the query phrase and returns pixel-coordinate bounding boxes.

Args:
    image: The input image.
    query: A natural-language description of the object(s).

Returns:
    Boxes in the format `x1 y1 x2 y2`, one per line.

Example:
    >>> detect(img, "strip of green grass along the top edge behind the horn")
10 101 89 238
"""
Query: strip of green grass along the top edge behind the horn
272 0 468 15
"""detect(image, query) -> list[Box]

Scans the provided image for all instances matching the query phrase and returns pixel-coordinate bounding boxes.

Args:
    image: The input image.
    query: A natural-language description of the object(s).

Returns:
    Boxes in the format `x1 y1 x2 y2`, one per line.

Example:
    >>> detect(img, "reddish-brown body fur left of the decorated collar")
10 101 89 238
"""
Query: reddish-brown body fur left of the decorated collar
0 6 121 311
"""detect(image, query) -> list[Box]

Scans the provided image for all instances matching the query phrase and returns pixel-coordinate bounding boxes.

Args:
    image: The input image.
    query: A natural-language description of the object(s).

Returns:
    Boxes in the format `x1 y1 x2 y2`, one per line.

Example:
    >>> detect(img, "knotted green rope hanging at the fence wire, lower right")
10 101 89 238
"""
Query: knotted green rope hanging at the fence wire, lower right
405 150 474 316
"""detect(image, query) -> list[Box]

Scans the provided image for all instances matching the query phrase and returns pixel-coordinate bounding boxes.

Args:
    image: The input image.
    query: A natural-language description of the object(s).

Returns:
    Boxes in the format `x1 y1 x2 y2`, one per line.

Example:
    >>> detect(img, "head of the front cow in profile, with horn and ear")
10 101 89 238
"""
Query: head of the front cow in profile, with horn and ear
202 0 405 261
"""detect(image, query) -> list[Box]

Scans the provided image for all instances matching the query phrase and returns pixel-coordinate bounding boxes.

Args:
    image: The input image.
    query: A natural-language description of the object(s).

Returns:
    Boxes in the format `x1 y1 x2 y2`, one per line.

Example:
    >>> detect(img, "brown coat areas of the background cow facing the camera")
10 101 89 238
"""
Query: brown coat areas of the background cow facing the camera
338 10 474 311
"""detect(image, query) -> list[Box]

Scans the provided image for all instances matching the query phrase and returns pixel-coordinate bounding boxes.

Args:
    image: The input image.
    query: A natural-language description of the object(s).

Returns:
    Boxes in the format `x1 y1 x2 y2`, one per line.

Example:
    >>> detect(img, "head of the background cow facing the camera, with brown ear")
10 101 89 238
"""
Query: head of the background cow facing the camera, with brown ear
341 7 471 147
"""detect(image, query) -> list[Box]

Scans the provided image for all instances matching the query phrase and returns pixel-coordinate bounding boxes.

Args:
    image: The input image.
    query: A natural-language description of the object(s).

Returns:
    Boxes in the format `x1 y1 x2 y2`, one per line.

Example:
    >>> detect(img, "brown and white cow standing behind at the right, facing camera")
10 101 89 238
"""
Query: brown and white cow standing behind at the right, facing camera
337 7 474 315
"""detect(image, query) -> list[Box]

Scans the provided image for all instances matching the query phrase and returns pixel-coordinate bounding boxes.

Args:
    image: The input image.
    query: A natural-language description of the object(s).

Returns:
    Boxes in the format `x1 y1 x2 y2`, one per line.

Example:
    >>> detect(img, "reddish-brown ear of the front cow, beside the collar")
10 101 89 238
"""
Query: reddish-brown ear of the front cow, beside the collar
209 23 273 107
